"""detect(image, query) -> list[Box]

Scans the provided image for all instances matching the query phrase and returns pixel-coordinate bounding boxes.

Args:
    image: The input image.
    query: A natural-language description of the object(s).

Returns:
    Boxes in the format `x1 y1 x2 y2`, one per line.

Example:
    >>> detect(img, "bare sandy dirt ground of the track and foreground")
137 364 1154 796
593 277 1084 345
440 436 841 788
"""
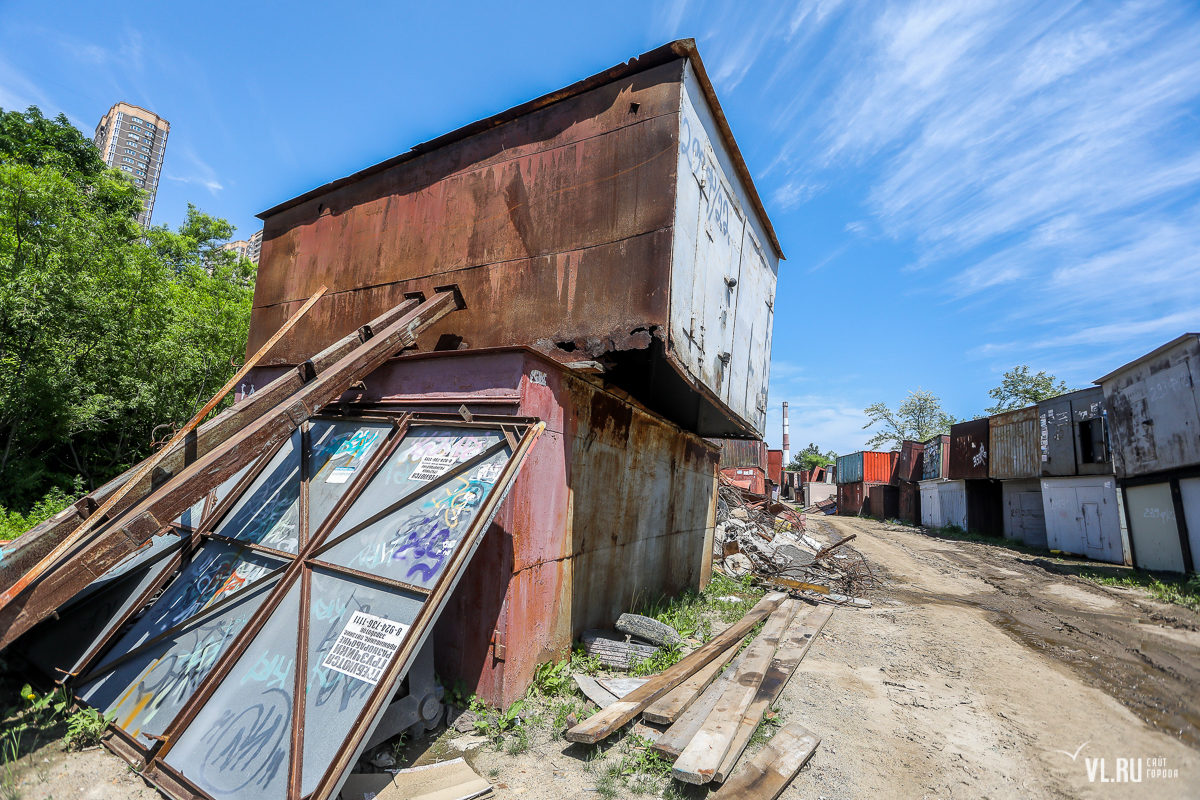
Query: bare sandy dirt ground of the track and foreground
4 517 1200 800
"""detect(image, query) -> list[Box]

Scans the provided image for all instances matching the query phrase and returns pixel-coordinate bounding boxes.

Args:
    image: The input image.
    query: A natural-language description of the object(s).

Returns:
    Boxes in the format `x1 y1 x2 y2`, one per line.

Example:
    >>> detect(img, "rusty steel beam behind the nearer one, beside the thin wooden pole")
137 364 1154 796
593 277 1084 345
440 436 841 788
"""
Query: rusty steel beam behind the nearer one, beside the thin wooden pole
0 295 425 609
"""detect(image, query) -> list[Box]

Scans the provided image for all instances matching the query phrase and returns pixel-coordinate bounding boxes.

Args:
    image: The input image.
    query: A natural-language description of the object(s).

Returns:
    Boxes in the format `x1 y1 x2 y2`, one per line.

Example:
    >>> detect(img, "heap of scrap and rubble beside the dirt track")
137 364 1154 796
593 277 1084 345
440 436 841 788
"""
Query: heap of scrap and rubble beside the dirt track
713 476 878 607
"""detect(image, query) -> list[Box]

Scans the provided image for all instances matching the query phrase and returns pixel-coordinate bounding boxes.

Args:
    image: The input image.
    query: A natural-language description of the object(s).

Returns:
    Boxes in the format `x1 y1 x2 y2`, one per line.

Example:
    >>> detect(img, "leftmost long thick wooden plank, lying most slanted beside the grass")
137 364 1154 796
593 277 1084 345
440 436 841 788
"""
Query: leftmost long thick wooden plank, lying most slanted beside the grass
566 591 787 745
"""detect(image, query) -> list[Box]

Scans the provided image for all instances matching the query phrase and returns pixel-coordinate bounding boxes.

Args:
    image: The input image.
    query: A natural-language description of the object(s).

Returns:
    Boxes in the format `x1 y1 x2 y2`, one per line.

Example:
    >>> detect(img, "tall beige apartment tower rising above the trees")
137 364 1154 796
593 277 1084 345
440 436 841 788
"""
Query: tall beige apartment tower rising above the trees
92 103 170 227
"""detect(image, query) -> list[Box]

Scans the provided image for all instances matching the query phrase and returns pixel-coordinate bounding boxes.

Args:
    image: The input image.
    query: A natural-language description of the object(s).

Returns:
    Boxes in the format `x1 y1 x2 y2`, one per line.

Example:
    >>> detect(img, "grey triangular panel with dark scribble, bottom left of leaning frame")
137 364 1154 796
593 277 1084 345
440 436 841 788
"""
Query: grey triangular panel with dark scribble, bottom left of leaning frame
166 583 300 800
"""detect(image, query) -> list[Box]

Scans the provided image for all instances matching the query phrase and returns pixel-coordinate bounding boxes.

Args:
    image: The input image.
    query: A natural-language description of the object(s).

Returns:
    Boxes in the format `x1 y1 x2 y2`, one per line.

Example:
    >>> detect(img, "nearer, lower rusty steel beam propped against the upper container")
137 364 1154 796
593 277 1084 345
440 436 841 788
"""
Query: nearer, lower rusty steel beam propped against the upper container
0 287 466 648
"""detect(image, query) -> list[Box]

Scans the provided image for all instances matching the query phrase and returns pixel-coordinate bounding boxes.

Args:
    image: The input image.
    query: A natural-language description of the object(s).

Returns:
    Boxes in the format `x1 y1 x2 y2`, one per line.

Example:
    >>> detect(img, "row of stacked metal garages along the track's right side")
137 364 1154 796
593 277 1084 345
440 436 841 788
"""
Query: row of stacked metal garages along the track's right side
836 333 1200 572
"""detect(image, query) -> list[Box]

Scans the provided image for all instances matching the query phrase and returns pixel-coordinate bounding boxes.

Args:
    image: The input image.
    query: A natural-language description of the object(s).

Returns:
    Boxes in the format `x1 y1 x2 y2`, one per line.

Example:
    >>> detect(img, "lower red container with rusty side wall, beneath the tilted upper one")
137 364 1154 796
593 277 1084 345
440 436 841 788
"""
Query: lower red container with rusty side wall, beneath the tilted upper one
341 348 719 708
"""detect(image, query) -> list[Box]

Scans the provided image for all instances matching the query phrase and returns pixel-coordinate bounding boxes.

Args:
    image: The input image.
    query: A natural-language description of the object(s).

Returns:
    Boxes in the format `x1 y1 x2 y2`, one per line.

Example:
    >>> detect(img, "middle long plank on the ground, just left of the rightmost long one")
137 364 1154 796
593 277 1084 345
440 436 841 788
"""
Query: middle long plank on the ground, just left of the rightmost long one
671 600 800 784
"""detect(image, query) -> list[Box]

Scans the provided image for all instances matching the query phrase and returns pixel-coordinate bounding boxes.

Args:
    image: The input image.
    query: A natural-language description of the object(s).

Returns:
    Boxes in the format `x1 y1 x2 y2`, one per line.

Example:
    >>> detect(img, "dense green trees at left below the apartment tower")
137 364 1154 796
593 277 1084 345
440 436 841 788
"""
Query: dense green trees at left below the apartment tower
0 108 254 509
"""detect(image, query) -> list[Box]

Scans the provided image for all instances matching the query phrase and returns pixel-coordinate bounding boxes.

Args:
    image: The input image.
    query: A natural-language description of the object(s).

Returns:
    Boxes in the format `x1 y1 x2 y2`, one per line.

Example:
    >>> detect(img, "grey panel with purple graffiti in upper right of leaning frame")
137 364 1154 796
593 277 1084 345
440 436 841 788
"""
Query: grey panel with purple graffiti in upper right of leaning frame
319 438 509 589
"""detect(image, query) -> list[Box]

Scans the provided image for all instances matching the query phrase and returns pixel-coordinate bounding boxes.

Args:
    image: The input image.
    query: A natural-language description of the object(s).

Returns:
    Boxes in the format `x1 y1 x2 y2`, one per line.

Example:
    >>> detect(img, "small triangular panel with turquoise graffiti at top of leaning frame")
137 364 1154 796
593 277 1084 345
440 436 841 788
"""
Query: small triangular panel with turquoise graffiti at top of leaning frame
308 420 391 533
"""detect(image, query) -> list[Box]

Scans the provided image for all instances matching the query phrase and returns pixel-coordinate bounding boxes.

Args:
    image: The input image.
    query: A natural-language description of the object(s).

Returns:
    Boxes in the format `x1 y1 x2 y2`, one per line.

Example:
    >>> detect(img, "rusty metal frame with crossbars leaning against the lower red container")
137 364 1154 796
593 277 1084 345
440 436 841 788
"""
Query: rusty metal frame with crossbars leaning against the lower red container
59 405 545 799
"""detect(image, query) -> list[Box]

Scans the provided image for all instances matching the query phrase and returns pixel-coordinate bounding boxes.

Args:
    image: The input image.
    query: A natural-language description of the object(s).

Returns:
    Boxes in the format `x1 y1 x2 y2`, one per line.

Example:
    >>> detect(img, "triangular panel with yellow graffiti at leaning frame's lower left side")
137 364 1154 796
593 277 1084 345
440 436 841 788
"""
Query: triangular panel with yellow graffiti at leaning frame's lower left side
77 563 278 747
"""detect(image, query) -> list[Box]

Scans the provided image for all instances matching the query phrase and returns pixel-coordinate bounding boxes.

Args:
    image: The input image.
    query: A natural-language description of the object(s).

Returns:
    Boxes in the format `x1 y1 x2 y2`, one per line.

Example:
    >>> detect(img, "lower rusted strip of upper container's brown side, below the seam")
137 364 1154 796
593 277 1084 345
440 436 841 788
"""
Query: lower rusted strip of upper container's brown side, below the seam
247 230 671 363
